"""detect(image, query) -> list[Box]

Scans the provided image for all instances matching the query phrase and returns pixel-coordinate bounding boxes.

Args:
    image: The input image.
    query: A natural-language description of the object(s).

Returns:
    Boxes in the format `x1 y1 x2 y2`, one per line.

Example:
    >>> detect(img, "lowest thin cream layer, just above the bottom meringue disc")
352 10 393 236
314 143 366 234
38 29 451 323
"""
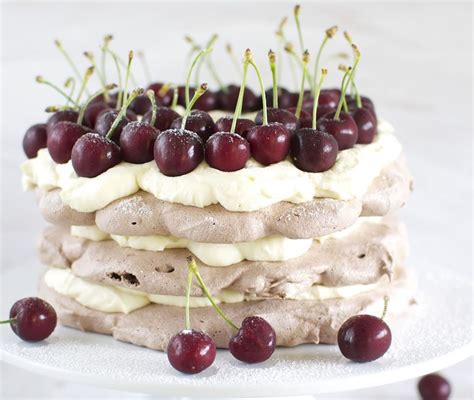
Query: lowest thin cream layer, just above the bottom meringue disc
44 268 378 314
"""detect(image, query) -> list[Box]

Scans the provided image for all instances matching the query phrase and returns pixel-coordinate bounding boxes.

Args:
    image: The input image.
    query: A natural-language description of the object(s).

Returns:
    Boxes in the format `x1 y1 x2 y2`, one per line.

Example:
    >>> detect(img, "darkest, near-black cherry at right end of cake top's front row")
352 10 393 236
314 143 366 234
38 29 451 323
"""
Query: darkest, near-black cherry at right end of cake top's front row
290 128 339 172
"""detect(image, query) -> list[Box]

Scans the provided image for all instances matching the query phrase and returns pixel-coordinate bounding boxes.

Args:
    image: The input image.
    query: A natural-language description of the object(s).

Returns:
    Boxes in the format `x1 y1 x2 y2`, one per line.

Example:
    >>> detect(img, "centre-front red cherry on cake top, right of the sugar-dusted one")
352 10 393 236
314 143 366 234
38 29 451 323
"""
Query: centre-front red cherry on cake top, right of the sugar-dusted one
205 132 250 172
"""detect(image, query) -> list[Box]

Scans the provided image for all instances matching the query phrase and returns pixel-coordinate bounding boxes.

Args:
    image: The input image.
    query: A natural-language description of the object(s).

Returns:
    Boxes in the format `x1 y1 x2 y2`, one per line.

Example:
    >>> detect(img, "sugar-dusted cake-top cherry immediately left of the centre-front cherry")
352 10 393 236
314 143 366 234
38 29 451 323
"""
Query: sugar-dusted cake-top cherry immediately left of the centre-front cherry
154 129 204 176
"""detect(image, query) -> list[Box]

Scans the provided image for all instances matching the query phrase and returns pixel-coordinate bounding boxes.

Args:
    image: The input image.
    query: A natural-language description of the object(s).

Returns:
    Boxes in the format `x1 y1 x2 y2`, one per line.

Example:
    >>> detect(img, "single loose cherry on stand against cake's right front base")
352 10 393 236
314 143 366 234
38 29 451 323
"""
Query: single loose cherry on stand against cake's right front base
337 315 392 363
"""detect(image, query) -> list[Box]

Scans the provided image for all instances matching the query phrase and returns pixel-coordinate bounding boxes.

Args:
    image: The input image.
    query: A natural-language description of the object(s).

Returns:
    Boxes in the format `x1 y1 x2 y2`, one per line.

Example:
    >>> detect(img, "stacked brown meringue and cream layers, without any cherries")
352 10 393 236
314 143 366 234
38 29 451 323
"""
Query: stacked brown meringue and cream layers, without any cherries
22 116 414 349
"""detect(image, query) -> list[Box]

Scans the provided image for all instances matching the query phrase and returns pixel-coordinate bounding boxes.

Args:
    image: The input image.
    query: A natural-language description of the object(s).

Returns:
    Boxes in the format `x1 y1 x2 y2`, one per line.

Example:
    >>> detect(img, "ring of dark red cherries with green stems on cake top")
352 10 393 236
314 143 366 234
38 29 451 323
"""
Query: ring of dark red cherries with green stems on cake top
23 14 377 177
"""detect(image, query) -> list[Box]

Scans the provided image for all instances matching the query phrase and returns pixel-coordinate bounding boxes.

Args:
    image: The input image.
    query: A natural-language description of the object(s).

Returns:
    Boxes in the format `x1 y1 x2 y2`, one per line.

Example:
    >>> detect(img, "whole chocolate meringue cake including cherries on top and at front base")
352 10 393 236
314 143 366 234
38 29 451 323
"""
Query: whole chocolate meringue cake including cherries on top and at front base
14 3 414 373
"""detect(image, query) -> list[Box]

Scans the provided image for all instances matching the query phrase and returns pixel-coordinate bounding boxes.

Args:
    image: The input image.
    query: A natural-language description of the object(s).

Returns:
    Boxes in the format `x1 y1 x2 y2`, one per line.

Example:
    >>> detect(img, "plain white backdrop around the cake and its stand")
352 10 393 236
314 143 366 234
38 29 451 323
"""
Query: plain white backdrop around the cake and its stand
0 1 472 399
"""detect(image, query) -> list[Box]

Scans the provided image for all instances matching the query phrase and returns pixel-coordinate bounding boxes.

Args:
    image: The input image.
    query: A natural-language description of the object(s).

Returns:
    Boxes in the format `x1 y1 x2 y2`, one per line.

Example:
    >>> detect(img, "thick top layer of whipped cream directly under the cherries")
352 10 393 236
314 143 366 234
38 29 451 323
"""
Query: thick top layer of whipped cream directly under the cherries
21 120 401 212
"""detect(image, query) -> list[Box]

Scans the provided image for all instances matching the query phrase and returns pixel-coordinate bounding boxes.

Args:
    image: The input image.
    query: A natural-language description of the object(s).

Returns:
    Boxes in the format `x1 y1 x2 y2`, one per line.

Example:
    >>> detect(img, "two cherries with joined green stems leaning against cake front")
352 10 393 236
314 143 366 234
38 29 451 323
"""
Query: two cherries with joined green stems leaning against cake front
167 256 276 373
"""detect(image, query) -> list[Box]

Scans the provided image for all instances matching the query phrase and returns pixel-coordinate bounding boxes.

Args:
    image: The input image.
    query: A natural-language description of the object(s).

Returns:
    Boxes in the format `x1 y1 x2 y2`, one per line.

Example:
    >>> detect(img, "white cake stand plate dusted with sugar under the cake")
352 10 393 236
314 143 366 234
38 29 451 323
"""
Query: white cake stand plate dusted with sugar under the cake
0 267 473 398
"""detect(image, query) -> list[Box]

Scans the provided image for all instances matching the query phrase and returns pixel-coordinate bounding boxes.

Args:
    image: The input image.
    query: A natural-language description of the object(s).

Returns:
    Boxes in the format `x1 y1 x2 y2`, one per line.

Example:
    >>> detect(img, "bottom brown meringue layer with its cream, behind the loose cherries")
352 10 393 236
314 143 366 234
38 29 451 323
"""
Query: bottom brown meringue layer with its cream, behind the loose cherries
39 268 415 350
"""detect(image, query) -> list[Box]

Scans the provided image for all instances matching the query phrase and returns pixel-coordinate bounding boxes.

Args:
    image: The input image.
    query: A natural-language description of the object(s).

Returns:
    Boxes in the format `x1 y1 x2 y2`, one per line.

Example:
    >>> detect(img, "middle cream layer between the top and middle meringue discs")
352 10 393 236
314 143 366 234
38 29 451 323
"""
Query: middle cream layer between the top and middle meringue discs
71 217 381 267
